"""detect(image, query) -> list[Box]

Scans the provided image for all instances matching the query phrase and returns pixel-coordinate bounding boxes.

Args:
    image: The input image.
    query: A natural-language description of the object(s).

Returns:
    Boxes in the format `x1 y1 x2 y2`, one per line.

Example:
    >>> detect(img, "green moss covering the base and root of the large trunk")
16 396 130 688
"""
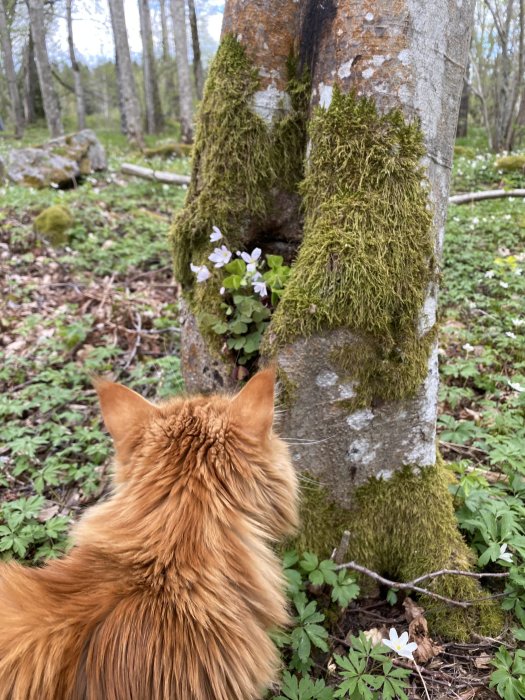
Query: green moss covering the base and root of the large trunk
297 460 503 641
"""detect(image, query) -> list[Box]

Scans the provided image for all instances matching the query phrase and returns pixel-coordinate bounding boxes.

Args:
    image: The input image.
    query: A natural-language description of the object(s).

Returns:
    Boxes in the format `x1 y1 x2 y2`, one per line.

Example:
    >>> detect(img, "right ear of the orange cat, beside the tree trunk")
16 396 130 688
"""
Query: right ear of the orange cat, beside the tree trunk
231 368 275 438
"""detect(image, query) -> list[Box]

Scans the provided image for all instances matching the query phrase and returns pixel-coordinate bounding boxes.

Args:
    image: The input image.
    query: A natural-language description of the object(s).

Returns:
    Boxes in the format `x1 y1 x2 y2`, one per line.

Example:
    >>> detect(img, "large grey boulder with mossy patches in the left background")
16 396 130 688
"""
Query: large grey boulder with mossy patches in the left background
5 129 107 189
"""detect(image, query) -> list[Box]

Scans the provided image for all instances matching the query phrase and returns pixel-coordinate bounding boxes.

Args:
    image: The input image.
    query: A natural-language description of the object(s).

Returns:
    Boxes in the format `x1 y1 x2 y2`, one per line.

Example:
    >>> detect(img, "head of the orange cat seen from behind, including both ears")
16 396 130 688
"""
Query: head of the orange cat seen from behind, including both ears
95 369 297 537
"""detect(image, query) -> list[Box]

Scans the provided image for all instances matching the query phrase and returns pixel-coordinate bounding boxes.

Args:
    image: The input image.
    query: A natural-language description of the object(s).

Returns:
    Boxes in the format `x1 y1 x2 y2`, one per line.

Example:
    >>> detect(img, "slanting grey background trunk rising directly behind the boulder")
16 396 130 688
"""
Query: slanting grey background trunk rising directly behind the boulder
27 0 64 138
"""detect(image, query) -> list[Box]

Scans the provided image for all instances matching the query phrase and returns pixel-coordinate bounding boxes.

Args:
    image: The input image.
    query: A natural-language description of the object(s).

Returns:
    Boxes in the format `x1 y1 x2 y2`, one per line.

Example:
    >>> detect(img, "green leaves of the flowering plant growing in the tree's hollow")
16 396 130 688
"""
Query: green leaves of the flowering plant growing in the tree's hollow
198 255 290 365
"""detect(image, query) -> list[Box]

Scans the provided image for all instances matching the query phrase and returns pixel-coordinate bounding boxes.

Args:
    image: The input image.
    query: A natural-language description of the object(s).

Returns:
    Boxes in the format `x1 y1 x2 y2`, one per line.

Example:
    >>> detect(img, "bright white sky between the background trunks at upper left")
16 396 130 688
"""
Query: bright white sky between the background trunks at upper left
52 0 222 64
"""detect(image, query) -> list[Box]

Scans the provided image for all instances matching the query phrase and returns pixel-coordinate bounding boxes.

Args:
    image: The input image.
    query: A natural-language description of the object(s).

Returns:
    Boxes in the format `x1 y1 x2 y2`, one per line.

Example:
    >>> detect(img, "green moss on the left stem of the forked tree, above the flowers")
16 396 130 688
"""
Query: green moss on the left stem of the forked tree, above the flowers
172 36 306 292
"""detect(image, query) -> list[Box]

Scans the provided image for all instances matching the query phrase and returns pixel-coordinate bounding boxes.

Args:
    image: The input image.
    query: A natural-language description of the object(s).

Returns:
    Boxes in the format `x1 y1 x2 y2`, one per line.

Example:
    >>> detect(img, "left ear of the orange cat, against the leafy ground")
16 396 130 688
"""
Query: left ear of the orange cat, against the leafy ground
93 379 158 450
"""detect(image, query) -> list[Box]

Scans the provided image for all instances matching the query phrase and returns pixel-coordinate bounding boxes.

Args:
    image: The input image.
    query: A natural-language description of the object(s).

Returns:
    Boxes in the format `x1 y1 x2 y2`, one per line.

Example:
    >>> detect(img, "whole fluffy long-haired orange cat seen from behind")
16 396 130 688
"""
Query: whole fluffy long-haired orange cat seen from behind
0 370 297 700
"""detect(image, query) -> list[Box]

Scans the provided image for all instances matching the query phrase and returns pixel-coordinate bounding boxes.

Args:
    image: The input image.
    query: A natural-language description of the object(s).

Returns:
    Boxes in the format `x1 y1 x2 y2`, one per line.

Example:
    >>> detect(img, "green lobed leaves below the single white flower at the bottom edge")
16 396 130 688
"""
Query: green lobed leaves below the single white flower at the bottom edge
334 633 411 700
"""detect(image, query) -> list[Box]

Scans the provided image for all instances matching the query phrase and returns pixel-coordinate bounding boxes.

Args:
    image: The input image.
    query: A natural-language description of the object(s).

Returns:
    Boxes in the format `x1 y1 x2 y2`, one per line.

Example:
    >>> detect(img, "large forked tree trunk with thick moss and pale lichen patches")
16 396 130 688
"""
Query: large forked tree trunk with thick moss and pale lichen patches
170 0 497 637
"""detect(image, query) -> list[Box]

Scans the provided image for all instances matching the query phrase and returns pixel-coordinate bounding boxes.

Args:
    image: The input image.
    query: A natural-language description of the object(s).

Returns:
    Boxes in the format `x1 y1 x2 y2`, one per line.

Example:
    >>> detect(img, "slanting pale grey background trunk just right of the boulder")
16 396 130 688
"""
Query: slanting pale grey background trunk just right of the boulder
108 0 144 148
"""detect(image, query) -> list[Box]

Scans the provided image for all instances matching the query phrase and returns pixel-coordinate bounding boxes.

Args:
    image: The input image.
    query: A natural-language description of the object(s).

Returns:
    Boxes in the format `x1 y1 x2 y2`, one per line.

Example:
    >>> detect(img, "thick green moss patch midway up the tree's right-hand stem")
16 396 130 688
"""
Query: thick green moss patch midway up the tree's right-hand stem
263 89 435 404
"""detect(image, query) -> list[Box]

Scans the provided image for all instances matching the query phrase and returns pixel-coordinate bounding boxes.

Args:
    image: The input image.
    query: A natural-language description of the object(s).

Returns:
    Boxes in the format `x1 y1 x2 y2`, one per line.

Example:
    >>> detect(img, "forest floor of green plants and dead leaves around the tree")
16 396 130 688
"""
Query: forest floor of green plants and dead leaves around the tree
0 123 525 700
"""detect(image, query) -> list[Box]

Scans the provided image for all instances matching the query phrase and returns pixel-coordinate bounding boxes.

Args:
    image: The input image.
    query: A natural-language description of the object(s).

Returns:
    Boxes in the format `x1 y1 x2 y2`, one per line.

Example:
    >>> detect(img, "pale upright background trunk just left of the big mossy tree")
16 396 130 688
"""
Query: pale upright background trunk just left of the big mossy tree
171 0 193 143
